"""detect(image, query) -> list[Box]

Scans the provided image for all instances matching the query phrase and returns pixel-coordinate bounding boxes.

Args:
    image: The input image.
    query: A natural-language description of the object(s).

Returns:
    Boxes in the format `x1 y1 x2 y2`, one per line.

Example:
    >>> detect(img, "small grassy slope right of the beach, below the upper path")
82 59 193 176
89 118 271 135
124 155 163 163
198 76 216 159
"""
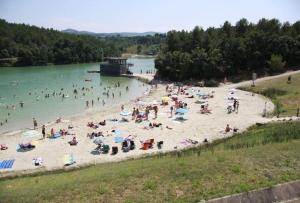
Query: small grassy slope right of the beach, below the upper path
241 73 300 116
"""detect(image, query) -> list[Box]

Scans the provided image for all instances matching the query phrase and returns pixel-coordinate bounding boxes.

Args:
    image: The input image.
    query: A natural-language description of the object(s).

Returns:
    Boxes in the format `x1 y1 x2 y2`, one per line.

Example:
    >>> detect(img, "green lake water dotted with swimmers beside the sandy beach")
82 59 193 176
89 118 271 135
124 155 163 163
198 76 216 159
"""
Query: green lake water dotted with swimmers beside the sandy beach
0 58 154 133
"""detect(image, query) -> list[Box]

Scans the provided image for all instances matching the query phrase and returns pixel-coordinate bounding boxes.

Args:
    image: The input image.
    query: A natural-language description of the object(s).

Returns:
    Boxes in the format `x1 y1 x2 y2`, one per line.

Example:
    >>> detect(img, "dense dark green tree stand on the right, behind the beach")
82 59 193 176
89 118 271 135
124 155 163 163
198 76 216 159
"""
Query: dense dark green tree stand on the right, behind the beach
155 19 300 81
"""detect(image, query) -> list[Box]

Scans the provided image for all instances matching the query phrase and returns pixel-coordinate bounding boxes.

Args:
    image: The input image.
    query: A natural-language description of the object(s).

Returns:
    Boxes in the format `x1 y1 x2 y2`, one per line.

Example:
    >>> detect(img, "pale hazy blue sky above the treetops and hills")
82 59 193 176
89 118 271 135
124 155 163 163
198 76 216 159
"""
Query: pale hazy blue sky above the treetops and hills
0 0 300 32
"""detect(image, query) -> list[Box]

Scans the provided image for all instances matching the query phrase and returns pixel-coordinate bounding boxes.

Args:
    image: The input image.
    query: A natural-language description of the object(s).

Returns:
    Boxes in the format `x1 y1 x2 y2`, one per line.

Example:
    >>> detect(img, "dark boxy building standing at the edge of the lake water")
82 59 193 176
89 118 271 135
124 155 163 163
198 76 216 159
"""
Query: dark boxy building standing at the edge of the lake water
100 57 132 76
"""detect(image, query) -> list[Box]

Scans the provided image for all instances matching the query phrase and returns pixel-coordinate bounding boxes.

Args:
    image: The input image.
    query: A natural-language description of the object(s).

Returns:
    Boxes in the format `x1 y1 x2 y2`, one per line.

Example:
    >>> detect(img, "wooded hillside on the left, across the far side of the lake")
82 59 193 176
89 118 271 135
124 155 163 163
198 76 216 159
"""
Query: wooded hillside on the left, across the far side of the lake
0 19 165 66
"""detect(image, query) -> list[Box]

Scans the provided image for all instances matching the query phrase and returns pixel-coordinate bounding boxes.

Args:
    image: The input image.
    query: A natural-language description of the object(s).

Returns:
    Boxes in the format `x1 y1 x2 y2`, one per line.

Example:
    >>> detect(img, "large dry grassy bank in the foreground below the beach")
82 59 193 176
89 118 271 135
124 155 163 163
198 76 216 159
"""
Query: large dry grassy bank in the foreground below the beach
0 122 300 202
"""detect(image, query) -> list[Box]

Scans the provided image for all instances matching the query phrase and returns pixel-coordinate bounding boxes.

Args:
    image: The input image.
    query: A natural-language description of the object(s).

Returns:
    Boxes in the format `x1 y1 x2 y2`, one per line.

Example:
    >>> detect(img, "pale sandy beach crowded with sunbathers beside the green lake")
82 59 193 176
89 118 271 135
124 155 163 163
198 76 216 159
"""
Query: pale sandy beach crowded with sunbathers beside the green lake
0 73 298 176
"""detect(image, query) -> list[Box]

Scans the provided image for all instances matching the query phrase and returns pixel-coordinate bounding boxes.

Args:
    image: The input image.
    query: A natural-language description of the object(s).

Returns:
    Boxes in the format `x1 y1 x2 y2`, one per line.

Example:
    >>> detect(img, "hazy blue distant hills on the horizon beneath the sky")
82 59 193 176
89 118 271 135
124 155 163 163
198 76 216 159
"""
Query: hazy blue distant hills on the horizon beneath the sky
61 29 160 37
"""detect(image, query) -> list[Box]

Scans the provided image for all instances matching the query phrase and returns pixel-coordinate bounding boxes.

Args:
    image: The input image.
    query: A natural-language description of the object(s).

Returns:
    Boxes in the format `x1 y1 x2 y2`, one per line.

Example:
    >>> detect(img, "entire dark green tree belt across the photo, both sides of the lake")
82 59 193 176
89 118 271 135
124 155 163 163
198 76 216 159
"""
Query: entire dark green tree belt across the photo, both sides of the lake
0 18 300 85
